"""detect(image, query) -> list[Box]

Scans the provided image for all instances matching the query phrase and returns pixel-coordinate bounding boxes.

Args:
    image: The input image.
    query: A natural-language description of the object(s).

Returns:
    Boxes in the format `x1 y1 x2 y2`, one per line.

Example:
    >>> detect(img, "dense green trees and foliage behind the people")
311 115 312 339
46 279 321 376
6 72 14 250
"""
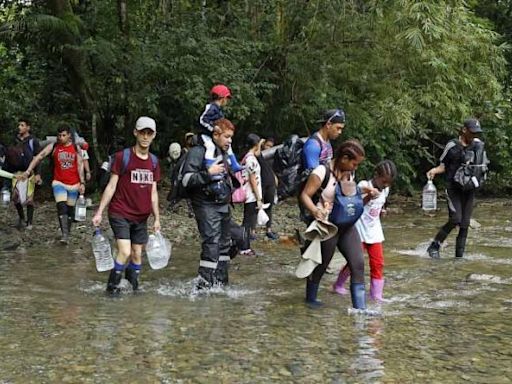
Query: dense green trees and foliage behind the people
0 0 512 192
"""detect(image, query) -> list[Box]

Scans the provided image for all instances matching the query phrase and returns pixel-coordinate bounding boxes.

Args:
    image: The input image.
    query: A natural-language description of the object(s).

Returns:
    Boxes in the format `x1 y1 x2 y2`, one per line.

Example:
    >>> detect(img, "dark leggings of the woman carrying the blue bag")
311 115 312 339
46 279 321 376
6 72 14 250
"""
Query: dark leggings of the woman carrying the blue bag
310 225 364 284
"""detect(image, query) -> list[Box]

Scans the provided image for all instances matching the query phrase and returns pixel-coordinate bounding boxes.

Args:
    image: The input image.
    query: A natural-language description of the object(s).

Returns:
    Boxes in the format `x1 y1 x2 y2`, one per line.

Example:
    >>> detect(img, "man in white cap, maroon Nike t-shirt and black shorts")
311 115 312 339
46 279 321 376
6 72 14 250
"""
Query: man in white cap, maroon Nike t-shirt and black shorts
92 116 160 295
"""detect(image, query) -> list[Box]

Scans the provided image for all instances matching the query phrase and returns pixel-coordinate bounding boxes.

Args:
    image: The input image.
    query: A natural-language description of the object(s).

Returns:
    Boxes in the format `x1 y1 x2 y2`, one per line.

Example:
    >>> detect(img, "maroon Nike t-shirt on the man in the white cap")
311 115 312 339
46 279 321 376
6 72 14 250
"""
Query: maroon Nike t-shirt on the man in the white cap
108 148 160 223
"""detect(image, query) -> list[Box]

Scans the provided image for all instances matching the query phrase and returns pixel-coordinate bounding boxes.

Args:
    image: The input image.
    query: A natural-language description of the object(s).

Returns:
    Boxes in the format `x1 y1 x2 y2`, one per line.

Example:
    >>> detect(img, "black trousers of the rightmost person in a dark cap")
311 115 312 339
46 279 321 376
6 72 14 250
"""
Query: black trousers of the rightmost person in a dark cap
435 188 475 243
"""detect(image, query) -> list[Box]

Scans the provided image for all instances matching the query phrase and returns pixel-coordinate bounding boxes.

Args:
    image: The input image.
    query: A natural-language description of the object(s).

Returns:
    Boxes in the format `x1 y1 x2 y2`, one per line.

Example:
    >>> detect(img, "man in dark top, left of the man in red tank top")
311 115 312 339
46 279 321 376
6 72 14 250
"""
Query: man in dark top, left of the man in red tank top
6 118 42 230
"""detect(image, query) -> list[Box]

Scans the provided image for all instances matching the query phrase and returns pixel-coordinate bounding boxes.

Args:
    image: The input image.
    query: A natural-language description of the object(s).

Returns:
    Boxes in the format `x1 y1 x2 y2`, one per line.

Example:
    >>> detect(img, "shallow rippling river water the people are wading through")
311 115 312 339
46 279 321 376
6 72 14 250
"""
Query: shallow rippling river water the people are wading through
0 201 512 384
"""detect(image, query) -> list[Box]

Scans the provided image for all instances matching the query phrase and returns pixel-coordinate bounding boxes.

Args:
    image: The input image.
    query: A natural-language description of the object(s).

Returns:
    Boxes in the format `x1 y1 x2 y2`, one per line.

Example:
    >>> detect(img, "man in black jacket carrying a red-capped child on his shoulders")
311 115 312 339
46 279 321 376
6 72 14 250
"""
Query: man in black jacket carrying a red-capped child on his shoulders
182 118 235 289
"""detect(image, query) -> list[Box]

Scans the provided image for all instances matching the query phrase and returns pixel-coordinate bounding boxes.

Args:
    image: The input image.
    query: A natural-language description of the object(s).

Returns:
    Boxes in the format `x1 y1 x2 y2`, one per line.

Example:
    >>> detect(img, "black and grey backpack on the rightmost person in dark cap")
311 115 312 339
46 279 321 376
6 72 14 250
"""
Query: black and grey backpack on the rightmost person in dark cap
453 139 489 191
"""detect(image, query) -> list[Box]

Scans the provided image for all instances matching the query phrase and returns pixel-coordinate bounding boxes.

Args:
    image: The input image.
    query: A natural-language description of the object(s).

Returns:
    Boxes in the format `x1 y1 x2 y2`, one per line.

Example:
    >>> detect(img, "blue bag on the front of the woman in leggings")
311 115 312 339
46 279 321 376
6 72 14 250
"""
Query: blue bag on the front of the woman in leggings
329 183 364 226
